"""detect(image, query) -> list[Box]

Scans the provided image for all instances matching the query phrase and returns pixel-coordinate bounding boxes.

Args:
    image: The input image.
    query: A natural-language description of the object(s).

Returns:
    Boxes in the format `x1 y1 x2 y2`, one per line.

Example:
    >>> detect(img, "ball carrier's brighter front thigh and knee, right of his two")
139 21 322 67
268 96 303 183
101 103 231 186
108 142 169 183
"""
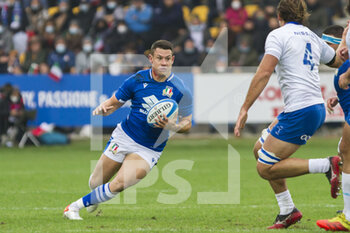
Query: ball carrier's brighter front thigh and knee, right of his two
111 153 151 191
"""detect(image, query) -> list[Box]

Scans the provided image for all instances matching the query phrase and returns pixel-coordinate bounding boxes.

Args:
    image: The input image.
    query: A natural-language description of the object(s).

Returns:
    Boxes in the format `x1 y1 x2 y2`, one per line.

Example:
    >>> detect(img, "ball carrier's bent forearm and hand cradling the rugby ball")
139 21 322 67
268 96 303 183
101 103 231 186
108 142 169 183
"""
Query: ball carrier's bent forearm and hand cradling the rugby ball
155 114 192 133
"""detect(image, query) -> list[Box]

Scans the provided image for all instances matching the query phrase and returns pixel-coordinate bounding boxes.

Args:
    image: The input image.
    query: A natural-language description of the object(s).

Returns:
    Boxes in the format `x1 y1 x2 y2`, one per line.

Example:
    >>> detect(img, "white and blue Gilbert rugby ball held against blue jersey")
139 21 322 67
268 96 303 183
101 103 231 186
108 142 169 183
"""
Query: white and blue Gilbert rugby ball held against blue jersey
147 99 178 127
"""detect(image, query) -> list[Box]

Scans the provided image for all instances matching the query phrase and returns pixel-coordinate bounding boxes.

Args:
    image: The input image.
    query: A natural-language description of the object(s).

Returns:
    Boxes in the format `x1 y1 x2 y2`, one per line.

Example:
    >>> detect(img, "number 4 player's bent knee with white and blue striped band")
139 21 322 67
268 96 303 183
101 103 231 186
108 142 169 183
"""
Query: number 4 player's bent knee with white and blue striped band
257 148 281 180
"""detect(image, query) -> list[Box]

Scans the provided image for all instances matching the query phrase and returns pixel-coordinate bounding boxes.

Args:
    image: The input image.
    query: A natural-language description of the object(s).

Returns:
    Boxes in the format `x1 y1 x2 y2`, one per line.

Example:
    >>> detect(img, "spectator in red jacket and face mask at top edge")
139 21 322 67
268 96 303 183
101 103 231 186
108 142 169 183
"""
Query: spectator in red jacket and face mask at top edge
225 0 248 32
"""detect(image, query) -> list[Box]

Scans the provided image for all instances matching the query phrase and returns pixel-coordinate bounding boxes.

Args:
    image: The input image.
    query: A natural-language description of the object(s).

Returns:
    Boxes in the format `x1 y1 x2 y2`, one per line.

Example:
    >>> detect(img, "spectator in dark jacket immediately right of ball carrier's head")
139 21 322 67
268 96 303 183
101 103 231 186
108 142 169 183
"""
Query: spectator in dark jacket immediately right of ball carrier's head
175 38 199 66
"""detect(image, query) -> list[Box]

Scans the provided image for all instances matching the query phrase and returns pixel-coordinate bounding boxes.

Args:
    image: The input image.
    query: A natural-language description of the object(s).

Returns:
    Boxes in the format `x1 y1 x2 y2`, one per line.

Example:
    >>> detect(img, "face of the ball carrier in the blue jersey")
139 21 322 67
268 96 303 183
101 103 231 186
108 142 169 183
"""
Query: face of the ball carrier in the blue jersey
149 48 175 77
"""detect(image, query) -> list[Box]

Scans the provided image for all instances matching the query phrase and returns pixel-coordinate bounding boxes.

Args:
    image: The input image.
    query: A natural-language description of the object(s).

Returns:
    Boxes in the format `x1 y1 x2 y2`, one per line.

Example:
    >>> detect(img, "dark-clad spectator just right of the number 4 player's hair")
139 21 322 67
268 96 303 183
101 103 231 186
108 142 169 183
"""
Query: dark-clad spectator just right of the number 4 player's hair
306 0 328 36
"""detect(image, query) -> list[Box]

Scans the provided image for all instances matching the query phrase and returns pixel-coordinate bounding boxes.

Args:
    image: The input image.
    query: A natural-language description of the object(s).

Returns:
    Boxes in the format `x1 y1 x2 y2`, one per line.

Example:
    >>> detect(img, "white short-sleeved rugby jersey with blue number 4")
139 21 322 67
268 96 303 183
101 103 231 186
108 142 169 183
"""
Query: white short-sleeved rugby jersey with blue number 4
265 23 335 112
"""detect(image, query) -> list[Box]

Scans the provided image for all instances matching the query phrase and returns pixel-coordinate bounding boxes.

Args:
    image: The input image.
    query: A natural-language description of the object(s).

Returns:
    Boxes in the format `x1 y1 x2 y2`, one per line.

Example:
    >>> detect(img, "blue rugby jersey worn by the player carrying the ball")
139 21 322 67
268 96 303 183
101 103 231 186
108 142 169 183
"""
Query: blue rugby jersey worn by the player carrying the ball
115 69 192 151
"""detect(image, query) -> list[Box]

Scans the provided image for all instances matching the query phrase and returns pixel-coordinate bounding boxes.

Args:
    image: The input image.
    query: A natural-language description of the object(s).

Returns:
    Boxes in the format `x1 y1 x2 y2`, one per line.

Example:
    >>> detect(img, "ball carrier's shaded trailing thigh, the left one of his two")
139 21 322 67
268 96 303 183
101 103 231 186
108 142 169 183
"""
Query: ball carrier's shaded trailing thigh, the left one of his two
90 154 122 186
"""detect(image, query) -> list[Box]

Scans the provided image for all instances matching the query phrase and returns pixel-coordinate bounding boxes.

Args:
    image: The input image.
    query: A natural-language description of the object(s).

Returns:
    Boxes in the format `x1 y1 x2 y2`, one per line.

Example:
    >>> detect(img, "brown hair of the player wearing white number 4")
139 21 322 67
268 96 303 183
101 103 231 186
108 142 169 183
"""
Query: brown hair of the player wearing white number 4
277 0 310 24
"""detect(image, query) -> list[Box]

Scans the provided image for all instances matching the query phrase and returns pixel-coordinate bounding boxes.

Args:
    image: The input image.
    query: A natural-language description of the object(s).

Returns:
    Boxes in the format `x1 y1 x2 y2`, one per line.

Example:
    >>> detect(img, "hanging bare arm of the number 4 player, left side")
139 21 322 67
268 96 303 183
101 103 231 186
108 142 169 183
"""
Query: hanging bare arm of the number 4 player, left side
234 54 278 136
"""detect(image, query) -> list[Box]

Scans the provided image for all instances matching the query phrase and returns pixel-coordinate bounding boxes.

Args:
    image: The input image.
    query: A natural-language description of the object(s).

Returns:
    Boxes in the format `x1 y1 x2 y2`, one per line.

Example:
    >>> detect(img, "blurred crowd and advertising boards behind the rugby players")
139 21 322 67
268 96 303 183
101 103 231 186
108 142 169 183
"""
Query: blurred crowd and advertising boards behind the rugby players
0 0 347 147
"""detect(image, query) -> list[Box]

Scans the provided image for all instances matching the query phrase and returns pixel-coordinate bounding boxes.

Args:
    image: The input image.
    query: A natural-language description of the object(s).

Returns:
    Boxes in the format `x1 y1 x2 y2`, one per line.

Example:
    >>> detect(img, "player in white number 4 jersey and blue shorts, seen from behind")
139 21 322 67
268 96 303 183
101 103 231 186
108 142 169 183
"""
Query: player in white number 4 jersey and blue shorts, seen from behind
234 0 343 229
